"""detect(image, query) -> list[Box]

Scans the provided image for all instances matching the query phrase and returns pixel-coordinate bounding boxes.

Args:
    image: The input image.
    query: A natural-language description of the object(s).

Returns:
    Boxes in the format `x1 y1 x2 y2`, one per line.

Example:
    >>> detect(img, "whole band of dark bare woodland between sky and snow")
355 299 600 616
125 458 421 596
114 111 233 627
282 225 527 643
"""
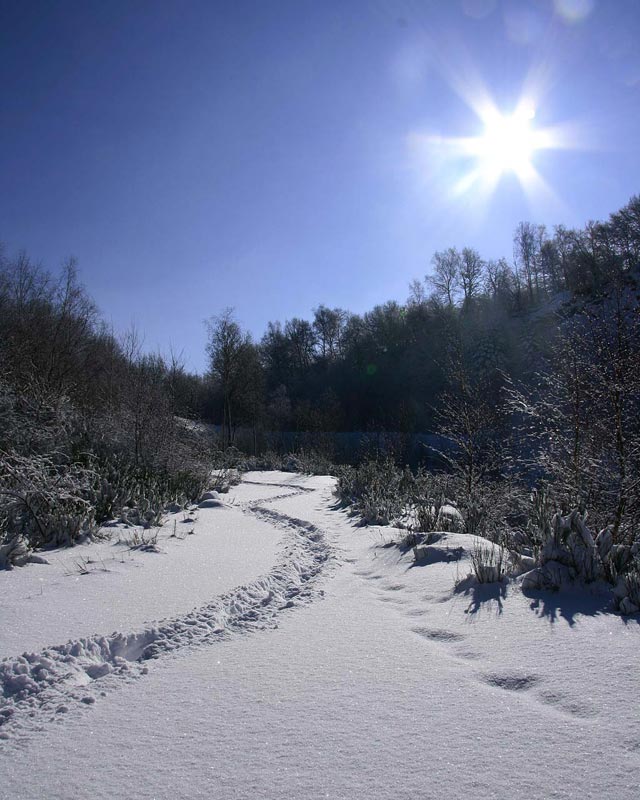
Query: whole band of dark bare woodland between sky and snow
0 196 640 600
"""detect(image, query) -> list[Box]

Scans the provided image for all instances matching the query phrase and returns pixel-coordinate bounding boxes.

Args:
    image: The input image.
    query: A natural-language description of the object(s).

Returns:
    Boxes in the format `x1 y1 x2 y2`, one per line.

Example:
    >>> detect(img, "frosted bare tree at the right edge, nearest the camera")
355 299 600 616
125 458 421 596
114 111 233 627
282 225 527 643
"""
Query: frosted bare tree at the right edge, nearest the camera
512 289 640 541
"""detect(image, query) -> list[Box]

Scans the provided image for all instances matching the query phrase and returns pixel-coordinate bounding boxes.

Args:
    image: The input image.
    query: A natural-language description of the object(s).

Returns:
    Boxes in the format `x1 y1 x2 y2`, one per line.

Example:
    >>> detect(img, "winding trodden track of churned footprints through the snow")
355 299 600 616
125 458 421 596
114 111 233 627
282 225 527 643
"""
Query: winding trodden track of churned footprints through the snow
0 484 333 740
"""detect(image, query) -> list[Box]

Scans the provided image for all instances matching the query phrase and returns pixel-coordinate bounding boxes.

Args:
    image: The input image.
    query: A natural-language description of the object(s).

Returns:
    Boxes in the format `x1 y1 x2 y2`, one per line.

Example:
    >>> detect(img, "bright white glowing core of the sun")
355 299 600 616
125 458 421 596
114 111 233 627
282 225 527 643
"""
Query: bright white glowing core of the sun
473 107 538 177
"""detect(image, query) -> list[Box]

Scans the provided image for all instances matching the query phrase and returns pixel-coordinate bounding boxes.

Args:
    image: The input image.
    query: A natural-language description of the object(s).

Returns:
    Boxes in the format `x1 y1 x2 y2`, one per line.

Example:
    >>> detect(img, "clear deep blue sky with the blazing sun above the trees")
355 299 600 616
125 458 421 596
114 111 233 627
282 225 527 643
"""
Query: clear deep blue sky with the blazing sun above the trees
0 0 640 370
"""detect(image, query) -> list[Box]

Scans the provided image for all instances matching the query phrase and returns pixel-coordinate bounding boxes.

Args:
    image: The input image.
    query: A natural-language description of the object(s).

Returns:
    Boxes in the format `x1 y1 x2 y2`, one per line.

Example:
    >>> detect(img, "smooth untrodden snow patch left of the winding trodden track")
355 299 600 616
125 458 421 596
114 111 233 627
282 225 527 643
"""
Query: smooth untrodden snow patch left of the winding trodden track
0 490 290 657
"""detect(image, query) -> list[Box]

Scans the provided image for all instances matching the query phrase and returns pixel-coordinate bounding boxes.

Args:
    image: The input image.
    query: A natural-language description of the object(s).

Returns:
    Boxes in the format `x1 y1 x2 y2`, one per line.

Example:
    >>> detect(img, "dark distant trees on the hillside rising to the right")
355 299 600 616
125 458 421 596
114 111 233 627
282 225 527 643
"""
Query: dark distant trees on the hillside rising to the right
205 192 640 444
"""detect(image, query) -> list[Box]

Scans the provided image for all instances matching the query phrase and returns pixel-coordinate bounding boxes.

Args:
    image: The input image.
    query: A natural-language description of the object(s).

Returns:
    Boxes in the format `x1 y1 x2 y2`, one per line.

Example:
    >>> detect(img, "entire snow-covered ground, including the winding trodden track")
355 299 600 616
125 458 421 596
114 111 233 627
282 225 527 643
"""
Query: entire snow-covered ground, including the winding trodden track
0 473 640 800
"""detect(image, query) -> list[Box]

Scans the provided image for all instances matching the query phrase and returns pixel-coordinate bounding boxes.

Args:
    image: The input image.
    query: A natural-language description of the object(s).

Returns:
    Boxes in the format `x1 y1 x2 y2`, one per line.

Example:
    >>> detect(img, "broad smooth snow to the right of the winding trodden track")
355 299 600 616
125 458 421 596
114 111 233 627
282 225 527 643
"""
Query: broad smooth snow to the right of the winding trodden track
0 473 640 800
